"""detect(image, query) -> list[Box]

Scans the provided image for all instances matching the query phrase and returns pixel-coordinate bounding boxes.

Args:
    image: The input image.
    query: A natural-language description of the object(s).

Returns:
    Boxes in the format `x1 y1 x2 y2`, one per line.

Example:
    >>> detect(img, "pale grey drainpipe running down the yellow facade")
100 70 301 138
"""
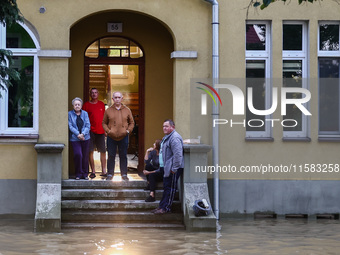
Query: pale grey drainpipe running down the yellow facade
204 0 220 219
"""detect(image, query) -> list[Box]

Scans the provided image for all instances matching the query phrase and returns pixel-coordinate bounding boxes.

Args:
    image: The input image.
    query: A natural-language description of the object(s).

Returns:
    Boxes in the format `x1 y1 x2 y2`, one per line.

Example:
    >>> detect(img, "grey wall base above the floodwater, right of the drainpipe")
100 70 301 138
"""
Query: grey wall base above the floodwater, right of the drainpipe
216 180 340 216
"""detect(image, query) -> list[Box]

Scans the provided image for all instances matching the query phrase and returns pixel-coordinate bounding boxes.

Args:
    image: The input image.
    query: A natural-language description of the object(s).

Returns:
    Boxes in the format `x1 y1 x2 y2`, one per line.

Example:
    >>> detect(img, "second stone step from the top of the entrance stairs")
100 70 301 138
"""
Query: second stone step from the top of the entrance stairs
61 189 178 200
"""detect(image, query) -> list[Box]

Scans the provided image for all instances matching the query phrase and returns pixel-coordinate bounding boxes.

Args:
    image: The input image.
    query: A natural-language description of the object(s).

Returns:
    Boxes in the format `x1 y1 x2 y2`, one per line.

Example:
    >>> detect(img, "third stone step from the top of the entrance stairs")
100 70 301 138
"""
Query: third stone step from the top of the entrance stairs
61 200 181 212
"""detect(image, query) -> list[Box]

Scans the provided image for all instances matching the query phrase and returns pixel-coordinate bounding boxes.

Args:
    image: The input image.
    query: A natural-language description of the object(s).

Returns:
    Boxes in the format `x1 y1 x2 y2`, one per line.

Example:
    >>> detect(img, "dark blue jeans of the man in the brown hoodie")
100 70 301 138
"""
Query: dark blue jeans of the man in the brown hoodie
107 135 129 176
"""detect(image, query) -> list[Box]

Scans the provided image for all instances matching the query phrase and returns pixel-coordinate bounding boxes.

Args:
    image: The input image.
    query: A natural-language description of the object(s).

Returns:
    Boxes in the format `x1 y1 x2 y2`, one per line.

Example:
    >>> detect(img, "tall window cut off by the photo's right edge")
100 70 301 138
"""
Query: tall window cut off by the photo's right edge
318 22 340 138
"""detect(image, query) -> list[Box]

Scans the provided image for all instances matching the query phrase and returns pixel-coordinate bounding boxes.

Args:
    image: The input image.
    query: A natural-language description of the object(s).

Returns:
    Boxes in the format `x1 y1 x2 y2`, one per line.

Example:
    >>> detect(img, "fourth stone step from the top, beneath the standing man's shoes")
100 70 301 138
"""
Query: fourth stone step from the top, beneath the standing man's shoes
61 211 183 224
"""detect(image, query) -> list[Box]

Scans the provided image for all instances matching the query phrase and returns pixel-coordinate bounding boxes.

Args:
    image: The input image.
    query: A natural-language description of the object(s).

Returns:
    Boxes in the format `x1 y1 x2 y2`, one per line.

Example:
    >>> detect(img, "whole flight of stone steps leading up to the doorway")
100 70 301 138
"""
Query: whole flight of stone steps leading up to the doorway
61 180 184 229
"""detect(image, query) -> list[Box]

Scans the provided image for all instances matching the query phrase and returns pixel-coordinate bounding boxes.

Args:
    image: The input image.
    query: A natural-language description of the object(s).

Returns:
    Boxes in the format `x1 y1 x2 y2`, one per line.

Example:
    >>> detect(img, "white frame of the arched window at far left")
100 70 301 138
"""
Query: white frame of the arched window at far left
0 22 40 138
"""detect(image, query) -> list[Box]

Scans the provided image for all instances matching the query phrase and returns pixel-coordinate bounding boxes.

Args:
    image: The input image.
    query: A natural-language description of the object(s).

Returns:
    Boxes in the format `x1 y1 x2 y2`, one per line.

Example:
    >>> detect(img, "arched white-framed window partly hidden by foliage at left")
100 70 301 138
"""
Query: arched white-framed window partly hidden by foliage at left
0 24 39 137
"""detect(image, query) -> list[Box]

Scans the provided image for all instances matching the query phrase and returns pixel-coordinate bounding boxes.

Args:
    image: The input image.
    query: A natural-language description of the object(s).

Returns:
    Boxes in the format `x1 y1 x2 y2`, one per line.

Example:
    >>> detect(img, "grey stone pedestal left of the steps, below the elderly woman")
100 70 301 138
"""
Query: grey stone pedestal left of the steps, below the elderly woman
34 144 65 232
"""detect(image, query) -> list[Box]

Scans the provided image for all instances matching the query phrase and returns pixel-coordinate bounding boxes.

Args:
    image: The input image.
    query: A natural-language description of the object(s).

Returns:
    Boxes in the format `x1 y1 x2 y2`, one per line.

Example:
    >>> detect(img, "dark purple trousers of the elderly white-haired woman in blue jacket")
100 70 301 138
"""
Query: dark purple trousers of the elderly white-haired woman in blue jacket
71 140 90 178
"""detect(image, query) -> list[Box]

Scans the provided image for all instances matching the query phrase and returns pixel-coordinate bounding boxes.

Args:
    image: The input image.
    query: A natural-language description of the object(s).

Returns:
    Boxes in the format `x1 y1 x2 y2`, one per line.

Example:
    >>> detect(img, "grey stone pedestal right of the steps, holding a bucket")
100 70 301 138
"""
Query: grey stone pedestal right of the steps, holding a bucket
181 144 216 231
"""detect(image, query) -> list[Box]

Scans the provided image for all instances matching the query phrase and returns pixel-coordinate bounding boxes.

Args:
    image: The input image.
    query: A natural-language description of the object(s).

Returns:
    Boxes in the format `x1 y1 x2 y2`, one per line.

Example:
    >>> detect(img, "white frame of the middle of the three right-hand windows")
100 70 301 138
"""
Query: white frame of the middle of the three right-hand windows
282 21 310 139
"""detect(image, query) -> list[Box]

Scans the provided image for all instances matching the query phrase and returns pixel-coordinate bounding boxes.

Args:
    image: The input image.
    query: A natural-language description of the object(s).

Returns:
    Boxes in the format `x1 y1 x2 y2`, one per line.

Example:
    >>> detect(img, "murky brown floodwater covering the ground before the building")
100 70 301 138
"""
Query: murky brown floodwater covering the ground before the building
0 219 340 255
